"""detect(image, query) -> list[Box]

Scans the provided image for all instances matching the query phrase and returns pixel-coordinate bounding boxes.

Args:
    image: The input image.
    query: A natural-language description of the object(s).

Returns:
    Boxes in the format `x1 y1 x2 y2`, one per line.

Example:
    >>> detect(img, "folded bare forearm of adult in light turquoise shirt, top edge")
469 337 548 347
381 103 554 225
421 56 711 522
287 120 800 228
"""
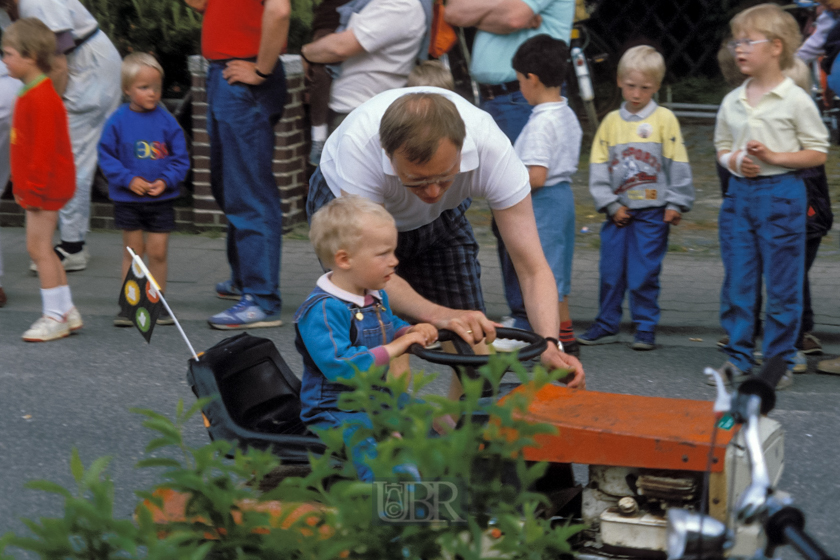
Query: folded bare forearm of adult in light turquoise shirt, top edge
444 0 540 35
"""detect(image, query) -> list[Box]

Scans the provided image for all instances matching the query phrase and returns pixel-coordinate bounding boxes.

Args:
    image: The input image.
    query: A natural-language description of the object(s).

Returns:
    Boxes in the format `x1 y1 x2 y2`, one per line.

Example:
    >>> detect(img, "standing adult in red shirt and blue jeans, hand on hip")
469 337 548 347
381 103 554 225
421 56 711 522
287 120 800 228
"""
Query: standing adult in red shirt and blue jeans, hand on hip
186 0 291 329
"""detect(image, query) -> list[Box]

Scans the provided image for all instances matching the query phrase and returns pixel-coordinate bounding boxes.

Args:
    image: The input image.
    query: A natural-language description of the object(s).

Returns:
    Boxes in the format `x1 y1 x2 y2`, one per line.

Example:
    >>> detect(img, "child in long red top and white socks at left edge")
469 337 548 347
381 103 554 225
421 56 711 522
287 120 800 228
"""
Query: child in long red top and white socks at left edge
2 18 82 342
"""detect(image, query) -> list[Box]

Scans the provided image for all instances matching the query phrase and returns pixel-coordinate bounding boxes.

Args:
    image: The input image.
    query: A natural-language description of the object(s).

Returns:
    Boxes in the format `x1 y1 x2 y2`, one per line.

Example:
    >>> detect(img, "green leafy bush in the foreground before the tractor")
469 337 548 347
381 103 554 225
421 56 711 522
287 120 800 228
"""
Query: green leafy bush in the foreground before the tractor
0 358 580 560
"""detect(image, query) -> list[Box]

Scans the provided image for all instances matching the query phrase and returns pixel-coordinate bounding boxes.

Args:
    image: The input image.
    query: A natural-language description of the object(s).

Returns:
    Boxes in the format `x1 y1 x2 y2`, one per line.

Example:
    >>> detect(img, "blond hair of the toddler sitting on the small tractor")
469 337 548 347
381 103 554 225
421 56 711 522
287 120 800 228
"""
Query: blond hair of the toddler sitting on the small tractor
309 194 394 266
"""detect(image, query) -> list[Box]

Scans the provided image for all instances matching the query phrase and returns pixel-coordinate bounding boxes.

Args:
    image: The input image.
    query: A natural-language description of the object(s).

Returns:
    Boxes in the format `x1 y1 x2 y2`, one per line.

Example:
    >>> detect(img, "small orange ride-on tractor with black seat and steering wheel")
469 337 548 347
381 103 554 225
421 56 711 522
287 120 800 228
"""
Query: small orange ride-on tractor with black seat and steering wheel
148 329 784 558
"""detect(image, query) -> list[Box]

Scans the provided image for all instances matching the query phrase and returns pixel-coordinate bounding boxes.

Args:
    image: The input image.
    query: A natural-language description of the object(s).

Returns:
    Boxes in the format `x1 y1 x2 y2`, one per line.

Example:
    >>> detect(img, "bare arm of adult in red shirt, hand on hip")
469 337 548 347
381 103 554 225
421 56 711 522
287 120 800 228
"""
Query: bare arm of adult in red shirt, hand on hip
222 0 292 85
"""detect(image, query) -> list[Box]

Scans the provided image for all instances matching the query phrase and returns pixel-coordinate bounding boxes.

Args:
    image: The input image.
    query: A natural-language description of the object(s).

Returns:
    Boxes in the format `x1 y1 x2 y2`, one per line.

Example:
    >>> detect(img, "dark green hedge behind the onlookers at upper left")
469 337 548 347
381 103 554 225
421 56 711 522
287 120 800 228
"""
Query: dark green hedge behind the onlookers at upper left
82 0 317 97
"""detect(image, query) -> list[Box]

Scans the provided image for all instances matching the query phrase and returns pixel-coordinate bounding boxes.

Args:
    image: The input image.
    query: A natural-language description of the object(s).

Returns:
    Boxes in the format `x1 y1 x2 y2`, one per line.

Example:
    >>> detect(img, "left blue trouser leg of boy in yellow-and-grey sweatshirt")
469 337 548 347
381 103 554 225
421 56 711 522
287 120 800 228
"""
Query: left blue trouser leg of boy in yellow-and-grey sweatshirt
595 218 629 333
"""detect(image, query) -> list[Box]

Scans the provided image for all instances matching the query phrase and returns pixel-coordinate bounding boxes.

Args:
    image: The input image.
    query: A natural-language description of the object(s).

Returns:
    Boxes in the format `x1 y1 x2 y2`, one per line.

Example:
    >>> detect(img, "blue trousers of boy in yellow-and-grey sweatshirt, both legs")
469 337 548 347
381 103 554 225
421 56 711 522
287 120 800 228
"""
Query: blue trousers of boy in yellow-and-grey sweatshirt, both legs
595 208 670 333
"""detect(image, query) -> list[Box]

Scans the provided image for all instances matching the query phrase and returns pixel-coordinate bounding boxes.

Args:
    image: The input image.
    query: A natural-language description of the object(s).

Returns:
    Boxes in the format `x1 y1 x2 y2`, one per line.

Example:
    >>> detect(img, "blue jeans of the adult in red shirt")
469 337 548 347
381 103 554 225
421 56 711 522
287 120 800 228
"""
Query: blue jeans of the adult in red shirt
207 62 286 314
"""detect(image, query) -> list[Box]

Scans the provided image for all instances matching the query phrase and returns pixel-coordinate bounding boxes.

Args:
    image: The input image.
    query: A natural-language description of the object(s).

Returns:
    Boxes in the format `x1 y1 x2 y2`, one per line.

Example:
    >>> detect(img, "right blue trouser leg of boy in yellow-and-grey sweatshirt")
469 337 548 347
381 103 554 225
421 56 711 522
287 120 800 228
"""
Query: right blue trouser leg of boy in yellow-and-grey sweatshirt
626 208 670 332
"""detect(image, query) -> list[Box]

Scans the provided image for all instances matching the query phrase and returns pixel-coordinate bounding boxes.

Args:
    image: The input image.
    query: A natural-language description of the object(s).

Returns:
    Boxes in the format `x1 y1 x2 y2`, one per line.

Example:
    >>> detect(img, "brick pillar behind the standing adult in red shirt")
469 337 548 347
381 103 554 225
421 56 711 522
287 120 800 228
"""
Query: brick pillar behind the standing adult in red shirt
189 55 309 231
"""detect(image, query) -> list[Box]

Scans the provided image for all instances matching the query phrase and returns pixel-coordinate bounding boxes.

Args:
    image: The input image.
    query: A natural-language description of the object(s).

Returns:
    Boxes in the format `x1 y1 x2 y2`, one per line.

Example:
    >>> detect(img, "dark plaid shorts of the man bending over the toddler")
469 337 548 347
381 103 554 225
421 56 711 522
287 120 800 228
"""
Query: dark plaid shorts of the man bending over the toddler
306 169 484 312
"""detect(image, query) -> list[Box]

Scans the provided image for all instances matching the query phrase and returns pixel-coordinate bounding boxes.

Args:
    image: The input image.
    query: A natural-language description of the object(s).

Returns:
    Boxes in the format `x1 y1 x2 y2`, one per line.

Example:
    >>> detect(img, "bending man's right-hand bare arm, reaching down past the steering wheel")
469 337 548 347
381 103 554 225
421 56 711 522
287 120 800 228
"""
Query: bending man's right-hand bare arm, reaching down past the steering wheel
493 196 586 388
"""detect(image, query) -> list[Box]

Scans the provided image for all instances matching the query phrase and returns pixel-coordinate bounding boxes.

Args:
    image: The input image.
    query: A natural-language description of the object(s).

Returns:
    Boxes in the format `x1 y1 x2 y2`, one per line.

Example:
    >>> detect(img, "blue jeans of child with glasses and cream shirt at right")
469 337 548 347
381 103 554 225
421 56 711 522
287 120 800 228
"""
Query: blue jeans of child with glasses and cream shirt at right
719 173 807 371
